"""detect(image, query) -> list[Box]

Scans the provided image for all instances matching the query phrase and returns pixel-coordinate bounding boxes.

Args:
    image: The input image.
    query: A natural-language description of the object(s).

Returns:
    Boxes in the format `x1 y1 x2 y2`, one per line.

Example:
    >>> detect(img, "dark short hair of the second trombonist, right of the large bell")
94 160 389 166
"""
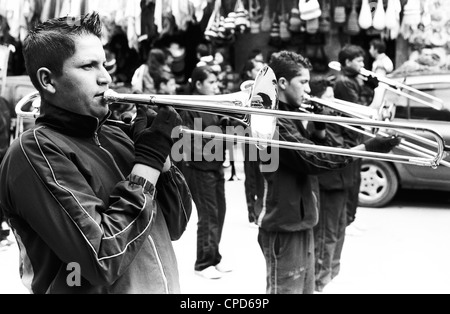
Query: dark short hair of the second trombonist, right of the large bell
269 51 312 81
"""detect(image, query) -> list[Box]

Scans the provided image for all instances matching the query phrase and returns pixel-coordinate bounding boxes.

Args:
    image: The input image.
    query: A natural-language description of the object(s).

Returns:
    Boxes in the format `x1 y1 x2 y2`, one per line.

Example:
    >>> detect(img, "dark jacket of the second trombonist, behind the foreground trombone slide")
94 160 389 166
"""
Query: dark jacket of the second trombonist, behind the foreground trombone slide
257 102 352 232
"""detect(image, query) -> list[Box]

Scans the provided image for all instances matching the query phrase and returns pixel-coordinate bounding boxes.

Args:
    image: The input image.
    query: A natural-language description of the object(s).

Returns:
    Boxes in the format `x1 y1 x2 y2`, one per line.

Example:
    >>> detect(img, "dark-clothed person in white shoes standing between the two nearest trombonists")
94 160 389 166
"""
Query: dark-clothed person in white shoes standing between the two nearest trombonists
181 66 231 279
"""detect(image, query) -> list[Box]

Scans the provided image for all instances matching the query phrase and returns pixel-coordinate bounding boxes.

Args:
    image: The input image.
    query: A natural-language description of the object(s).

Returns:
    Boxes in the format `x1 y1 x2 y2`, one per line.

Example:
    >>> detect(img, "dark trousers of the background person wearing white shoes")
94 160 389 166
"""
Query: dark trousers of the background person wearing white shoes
183 165 226 271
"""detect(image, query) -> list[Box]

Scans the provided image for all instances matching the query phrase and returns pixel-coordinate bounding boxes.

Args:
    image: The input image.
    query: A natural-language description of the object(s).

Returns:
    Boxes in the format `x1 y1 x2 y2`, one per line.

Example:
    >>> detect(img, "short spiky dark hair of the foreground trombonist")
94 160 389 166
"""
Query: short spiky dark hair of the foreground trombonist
23 12 102 90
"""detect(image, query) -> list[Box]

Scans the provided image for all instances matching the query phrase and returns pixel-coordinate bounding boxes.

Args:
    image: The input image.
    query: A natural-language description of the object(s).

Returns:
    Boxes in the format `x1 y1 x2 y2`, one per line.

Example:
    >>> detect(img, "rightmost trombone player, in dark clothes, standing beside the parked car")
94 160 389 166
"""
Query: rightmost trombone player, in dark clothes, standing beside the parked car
334 45 378 234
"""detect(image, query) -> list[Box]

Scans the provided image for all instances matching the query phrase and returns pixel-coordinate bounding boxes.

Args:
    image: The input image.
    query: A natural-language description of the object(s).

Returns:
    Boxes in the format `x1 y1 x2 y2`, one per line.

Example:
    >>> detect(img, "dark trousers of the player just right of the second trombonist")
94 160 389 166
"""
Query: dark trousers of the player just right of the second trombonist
314 190 348 291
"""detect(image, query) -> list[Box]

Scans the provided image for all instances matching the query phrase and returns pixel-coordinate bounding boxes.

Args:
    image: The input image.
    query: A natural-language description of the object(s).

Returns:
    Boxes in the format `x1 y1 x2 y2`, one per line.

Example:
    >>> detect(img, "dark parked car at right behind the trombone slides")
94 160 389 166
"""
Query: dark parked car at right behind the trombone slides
359 73 450 207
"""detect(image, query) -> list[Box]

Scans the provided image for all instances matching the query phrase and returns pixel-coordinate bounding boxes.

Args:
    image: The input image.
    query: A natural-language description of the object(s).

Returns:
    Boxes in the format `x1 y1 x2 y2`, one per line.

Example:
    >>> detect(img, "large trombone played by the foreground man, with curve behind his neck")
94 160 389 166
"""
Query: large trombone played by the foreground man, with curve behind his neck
16 66 446 168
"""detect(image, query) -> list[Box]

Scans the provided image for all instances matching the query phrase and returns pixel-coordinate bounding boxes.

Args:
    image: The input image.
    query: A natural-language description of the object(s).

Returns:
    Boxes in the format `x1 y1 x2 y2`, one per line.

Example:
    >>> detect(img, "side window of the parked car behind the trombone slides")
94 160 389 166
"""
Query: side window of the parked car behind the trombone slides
395 83 450 121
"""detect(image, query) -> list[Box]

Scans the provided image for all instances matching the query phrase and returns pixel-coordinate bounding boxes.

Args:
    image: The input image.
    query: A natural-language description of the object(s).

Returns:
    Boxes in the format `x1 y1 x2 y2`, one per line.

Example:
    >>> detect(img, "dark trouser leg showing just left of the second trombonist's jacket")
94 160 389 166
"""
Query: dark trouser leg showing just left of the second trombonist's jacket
244 161 264 222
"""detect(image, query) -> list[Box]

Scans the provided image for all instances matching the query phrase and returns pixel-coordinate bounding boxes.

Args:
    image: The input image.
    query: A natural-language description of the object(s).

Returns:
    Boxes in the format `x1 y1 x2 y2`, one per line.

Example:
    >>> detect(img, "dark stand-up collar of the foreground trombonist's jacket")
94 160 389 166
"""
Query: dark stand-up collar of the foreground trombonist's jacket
36 102 111 137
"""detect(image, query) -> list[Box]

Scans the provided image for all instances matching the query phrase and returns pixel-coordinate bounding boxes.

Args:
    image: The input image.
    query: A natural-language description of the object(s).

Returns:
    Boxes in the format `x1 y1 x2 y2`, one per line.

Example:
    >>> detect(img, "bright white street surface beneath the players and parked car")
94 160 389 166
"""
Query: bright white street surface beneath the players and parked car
0 157 450 295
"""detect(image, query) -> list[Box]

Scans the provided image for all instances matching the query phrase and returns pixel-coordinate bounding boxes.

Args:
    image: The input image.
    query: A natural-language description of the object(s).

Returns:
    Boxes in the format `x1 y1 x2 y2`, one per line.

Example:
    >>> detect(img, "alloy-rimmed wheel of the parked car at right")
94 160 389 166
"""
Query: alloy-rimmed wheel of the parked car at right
359 160 398 207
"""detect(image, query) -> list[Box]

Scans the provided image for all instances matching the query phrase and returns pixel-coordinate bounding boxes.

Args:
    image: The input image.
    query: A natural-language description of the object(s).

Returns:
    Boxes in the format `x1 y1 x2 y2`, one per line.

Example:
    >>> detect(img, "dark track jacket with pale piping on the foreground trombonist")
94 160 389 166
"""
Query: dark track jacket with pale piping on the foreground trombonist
0 104 192 294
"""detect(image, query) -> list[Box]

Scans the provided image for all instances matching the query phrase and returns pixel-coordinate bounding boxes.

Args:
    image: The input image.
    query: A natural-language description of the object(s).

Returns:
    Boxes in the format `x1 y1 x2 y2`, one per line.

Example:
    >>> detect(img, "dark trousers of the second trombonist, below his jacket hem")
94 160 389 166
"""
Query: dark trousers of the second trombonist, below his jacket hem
258 229 314 294
